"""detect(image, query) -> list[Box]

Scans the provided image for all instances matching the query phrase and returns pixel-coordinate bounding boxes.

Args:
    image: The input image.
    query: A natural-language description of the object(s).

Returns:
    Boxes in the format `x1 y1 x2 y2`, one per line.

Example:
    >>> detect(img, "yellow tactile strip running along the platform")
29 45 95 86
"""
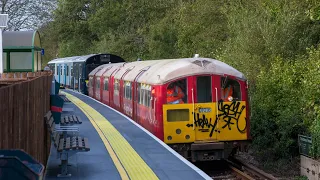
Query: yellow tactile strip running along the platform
64 92 158 180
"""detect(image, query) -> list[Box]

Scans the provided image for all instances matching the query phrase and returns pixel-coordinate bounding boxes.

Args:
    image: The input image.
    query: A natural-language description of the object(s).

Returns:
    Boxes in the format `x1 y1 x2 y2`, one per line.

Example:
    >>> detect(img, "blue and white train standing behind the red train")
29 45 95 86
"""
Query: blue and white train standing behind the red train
48 54 125 94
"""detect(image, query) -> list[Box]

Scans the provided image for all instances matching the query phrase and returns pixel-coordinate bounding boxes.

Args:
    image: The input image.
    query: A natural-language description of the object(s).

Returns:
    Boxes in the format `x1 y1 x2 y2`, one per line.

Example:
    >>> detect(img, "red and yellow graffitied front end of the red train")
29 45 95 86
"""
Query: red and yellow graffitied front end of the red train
157 59 250 162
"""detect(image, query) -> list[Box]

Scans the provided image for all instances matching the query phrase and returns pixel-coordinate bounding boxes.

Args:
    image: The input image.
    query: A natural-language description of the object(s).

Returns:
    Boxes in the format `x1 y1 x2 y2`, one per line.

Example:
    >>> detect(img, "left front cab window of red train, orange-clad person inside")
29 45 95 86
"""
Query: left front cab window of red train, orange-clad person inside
167 79 188 104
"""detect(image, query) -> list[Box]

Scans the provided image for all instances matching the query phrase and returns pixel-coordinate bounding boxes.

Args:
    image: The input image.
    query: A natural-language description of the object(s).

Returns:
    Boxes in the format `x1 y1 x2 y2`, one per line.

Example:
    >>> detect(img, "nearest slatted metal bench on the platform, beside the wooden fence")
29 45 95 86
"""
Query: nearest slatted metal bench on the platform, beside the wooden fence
45 112 90 177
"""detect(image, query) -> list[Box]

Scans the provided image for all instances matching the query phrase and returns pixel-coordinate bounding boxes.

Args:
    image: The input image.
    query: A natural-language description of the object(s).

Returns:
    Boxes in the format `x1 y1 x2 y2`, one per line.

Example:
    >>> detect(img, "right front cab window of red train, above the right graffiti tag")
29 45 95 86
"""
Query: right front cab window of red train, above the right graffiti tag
221 77 241 101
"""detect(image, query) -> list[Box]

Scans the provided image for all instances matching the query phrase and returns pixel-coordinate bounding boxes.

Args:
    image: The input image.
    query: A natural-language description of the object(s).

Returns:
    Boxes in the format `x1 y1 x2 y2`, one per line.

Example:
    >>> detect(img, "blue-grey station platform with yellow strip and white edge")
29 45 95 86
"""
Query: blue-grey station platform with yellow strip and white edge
45 90 212 180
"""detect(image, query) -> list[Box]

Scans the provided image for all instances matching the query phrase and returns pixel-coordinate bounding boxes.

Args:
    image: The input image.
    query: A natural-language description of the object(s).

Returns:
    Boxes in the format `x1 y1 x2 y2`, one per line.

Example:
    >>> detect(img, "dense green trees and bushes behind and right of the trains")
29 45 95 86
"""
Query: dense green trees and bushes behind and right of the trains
43 0 320 159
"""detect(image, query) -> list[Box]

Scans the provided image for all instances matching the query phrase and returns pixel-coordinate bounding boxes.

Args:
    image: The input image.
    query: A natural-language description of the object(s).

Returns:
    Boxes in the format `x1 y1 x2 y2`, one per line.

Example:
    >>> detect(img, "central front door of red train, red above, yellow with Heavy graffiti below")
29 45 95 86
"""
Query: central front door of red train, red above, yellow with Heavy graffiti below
192 75 218 141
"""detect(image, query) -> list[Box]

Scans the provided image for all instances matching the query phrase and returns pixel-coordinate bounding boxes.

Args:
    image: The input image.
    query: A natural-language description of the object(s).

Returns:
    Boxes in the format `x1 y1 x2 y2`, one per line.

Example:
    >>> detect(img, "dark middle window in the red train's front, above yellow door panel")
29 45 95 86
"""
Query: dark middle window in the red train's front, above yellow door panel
197 76 212 103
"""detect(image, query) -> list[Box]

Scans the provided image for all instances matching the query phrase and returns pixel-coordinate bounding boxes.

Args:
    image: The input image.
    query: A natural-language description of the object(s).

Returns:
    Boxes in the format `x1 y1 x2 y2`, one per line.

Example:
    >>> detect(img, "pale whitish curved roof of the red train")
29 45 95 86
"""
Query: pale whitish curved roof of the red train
91 58 246 84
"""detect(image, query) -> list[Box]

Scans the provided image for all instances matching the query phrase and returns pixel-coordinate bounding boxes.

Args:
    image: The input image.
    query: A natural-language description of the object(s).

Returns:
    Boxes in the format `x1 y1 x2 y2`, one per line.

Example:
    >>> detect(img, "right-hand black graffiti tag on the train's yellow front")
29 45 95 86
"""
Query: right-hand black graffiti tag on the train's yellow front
218 101 247 133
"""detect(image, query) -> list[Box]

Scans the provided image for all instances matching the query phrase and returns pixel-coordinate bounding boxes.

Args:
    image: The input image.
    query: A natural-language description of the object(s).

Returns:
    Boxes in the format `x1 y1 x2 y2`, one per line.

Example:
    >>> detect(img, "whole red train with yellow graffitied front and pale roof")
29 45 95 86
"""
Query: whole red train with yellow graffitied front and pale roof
90 57 251 162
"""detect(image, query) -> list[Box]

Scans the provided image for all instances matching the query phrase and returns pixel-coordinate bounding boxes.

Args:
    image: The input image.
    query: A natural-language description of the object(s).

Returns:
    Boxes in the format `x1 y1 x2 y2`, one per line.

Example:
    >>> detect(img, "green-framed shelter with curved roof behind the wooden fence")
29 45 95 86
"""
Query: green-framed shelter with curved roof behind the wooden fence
2 31 42 72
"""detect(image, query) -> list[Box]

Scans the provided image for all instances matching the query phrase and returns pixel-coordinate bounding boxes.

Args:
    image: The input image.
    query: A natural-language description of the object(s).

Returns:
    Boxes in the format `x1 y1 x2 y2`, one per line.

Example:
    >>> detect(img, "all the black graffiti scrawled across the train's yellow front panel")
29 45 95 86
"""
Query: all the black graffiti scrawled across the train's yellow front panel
187 101 247 137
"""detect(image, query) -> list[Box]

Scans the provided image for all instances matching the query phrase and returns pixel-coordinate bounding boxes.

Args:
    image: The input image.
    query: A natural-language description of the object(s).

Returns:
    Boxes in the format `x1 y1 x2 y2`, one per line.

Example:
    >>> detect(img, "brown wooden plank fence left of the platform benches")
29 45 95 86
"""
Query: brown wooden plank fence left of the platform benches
0 72 52 166
